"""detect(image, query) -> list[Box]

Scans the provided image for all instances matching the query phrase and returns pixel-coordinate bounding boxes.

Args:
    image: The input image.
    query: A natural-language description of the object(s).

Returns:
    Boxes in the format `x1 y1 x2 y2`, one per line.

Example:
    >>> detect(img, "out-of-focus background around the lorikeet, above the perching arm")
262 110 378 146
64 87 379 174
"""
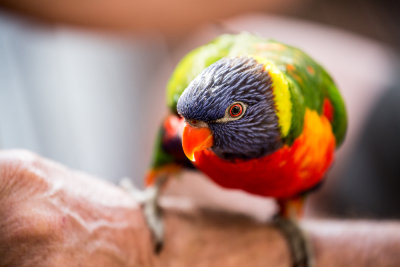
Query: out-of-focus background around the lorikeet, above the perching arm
0 0 400 218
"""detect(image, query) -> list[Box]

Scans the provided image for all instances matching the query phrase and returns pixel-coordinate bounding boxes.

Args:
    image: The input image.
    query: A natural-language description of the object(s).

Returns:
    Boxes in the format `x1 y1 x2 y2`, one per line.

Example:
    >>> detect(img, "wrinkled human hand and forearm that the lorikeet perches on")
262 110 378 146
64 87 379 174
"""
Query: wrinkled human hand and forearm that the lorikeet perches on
0 151 400 267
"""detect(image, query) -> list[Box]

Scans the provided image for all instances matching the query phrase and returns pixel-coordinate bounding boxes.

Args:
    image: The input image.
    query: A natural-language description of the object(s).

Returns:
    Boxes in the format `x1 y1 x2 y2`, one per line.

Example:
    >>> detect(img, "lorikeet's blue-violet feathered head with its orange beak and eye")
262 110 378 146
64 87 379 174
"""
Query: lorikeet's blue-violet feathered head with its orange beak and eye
177 57 282 161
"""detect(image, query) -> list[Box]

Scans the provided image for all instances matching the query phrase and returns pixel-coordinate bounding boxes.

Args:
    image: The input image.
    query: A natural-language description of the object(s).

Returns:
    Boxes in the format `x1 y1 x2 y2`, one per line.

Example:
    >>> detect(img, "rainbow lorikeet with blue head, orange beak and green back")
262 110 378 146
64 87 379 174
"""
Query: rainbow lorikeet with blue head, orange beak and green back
141 33 347 264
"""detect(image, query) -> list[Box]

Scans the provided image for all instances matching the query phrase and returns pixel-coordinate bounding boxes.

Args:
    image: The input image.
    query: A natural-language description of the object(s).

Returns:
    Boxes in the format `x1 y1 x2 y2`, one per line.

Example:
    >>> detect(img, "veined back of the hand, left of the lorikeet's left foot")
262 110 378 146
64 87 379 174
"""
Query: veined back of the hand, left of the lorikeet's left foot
0 151 153 267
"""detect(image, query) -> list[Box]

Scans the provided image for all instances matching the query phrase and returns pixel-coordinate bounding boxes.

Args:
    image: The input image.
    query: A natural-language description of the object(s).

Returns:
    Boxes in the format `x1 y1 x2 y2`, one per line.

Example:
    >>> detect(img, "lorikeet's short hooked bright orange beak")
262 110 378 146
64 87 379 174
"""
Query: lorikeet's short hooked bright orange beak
182 123 213 161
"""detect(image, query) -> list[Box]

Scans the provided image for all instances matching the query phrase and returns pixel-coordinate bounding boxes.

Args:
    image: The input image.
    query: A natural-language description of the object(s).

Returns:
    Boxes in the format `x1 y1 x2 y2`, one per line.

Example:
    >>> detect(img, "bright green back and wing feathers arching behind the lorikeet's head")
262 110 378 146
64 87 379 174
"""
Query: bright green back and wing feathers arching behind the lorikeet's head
167 33 347 149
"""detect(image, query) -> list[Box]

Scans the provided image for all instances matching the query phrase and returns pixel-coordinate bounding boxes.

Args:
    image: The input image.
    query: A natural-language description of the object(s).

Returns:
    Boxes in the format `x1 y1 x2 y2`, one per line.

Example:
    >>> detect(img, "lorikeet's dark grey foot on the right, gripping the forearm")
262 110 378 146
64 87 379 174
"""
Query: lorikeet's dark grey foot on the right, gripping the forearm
273 215 313 267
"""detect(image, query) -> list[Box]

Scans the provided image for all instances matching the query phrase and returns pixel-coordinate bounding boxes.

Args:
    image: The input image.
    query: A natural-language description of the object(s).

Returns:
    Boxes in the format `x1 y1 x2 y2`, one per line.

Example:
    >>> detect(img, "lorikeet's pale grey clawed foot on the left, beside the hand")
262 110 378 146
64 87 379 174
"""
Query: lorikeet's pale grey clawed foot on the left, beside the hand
120 178 166 254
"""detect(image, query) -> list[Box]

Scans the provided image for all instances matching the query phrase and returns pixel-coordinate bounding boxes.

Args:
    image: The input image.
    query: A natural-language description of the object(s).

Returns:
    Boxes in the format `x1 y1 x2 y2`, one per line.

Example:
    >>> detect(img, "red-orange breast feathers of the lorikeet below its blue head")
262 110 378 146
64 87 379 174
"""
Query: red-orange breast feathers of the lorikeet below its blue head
194 110 335 198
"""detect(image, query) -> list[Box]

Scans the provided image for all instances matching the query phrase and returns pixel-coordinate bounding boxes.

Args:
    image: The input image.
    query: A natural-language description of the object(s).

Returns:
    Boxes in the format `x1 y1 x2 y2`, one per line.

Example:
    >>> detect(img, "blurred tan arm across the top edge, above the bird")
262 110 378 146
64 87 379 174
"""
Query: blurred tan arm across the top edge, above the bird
0 0 298 35
